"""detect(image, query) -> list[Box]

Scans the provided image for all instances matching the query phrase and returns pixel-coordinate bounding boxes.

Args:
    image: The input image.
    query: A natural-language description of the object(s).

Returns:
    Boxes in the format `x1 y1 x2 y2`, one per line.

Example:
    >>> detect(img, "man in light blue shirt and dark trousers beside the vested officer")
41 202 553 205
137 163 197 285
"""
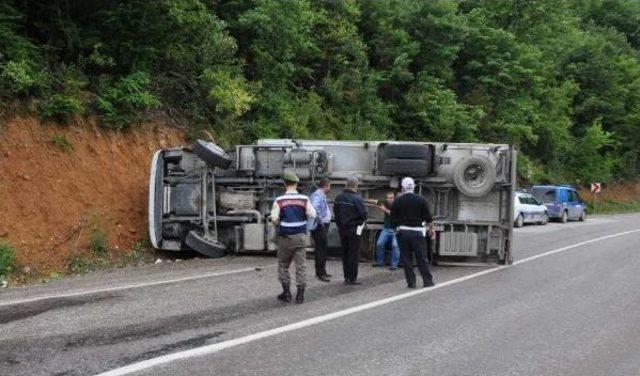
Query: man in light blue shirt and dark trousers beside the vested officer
309 178 331 282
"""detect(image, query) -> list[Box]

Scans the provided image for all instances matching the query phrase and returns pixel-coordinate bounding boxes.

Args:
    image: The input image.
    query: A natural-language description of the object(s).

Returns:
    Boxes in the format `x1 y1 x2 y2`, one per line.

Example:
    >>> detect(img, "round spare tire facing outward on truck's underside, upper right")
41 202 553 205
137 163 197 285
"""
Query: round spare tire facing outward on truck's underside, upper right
453 155 496 197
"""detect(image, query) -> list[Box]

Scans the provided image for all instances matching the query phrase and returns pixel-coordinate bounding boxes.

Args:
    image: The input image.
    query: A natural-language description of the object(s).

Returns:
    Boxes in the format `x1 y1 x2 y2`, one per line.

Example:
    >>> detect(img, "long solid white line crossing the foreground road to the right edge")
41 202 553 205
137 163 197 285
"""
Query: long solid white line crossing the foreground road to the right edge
97 229 640 376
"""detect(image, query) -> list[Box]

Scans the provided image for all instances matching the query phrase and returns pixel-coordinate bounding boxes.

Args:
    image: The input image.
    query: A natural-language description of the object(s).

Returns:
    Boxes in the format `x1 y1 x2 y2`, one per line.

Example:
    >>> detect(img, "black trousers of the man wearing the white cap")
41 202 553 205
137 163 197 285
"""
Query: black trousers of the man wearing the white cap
397 230 433 285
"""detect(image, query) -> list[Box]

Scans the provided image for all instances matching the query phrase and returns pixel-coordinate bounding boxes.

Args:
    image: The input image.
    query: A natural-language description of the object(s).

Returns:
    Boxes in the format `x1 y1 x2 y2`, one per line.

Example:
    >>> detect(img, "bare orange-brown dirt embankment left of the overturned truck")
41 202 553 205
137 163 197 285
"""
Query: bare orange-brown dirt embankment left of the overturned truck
0 118 185 272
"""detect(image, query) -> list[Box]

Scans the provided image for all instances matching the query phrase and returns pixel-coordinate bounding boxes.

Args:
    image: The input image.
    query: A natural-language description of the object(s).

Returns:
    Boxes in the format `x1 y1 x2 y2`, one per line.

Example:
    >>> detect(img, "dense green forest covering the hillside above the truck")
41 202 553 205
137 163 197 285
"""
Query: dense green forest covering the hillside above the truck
0 0 640 182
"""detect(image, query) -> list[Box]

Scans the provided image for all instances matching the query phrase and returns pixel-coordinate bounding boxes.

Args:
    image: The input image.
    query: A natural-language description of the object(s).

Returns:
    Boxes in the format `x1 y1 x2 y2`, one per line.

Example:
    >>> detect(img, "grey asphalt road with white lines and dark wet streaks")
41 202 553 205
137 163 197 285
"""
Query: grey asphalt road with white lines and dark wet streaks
0 215 640 376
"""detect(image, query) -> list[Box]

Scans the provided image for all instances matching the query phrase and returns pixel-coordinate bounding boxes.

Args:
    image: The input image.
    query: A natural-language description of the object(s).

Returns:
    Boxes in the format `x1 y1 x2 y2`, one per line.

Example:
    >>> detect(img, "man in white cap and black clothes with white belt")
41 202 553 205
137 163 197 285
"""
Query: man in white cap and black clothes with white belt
391 177 435 289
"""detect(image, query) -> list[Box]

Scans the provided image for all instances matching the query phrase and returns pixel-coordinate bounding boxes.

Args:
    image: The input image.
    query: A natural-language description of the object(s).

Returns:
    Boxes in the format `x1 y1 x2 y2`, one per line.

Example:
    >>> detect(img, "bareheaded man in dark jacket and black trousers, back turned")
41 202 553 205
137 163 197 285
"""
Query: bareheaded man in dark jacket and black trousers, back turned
333 177 367 285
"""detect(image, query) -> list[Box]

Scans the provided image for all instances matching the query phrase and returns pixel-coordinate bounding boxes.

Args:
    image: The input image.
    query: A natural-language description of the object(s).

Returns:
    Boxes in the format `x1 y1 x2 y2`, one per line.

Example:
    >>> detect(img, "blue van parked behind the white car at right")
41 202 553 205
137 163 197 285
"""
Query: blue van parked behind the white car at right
531 185 587 223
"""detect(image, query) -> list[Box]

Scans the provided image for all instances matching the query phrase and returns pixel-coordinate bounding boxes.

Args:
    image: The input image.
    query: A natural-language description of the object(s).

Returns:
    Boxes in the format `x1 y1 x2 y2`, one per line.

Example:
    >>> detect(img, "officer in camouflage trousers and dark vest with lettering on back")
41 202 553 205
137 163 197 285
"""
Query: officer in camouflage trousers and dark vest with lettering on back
271 172 316 303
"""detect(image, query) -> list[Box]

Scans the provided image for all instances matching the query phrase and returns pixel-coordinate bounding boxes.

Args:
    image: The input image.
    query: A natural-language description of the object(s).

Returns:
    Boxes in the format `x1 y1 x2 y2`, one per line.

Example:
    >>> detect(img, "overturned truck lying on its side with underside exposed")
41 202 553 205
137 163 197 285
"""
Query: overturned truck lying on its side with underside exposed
149 139 516 264
